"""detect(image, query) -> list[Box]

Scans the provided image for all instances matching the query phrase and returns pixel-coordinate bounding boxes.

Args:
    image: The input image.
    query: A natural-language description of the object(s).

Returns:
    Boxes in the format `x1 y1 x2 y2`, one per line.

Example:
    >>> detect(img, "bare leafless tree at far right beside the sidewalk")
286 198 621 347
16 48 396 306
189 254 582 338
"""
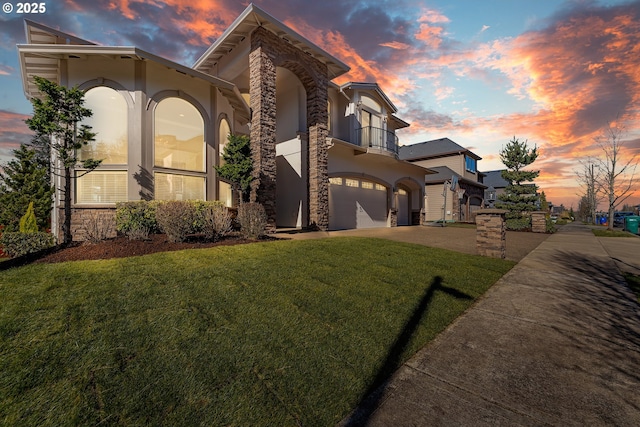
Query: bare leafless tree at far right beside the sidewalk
594 123 637 230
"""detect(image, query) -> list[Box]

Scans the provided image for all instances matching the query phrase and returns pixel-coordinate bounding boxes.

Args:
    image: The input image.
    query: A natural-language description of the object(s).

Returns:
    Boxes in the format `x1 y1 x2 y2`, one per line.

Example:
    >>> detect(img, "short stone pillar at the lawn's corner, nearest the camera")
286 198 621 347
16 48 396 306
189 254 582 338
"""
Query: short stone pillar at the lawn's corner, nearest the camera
476 209 507 258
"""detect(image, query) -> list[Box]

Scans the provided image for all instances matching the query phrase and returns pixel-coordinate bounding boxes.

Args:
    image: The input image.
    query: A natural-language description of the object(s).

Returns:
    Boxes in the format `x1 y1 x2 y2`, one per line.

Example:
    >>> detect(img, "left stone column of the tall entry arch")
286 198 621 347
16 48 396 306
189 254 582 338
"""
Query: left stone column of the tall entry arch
249 31 276 229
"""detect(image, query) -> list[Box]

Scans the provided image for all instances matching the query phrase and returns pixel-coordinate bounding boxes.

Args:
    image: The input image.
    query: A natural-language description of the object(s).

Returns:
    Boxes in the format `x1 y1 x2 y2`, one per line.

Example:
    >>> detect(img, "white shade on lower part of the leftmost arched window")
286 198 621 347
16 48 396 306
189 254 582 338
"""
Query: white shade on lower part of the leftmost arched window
76 170 127 204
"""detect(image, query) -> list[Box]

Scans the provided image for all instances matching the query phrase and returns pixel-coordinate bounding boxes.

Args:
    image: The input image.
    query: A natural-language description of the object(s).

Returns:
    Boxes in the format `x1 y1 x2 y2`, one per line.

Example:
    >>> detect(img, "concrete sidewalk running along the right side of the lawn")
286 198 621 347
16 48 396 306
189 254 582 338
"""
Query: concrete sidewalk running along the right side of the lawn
341 224 640 426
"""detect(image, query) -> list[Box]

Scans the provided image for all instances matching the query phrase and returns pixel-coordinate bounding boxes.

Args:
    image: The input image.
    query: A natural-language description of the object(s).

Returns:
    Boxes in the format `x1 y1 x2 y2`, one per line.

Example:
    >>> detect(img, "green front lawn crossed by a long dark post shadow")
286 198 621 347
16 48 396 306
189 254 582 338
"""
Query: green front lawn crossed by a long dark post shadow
0 238 514 426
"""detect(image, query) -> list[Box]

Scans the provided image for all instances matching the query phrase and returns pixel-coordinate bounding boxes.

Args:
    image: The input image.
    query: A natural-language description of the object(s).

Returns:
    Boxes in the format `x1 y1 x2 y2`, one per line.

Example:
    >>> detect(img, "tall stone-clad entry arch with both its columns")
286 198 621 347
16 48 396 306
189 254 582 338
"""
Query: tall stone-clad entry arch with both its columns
249 27 329 234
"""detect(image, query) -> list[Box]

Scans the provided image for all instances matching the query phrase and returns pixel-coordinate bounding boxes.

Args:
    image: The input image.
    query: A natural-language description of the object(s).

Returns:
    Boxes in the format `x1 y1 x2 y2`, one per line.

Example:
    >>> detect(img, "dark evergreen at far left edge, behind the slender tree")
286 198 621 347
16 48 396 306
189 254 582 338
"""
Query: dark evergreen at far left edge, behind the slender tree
0 144 53 231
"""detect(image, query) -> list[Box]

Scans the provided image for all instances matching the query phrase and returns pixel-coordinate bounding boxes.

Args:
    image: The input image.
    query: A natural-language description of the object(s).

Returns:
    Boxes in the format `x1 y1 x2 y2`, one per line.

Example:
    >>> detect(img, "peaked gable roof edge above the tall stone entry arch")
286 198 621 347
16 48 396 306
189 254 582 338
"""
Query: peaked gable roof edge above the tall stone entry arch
193 3 349 80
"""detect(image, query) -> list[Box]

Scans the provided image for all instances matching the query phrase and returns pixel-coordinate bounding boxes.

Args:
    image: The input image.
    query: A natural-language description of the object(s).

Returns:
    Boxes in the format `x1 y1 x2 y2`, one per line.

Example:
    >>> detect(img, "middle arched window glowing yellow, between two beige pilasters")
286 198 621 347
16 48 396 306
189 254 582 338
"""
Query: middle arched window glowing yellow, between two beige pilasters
154 98 206 200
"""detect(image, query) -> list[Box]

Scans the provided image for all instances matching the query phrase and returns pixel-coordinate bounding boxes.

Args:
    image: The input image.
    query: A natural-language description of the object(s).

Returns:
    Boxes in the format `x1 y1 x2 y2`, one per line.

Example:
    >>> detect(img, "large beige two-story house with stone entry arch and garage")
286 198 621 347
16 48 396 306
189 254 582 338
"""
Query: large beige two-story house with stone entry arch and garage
18 5 429 241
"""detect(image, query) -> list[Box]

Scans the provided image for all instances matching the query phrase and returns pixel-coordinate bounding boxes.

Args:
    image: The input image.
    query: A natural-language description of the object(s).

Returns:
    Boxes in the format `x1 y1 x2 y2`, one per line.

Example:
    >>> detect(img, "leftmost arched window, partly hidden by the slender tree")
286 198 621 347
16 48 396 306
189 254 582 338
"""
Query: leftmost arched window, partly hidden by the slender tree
76 86 129 204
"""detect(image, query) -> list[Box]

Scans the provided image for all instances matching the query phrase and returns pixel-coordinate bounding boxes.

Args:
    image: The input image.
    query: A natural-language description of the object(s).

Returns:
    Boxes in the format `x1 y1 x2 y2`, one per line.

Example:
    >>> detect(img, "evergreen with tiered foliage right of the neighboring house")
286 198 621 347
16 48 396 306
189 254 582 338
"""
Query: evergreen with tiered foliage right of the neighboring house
496 136 540 230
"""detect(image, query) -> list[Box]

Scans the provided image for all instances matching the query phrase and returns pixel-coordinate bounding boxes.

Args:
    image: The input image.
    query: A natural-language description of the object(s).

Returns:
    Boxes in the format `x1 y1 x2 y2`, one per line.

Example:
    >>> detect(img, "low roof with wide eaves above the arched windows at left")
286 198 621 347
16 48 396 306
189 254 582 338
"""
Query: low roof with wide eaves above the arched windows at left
17 21 251 120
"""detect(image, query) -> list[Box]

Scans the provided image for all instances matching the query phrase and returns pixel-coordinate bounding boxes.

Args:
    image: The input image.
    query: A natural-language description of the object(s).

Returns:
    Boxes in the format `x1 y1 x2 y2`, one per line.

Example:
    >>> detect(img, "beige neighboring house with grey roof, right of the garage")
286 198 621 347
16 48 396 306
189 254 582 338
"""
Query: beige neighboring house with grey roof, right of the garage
400 138 487 222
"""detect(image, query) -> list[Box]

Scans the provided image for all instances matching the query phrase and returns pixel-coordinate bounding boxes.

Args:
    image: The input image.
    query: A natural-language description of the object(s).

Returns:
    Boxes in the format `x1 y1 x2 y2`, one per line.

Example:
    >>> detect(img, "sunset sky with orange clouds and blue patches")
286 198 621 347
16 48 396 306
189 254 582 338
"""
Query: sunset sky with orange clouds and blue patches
0 0 640 209
